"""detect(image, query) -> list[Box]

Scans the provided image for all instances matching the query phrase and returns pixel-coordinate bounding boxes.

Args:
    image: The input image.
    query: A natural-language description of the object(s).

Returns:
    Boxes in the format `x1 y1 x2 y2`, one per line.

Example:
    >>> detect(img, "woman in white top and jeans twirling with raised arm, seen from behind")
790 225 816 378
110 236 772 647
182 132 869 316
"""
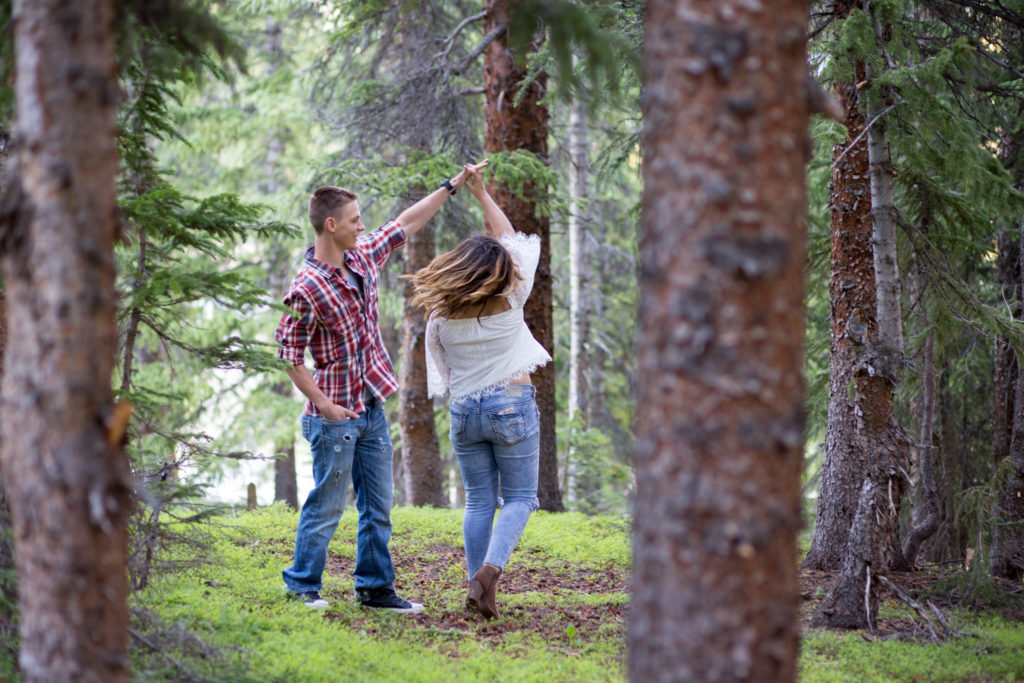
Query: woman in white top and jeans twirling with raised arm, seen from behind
413 166 551 618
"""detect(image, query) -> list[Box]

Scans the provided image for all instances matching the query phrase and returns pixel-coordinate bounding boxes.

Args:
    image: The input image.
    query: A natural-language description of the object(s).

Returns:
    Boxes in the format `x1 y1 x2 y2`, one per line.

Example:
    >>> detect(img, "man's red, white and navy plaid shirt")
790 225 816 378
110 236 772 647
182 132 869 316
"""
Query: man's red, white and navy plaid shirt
273 221 406 416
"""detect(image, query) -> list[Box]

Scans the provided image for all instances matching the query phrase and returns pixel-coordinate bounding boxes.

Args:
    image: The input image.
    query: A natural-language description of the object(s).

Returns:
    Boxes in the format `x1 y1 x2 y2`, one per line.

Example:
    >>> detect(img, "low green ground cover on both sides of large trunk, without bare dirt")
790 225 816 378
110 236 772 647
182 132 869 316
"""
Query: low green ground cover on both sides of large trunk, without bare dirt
119 505 1024 681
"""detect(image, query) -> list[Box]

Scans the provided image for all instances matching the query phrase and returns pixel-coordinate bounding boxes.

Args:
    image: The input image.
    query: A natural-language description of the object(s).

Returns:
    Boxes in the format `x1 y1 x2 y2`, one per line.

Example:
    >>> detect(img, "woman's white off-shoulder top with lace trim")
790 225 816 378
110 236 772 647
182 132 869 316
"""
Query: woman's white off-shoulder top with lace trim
426 232 551 397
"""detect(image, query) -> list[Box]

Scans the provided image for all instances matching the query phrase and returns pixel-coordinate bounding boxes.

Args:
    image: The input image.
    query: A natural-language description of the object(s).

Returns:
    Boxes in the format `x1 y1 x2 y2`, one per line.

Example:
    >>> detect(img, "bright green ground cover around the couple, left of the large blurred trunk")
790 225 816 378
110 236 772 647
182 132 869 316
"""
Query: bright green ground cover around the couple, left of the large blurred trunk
134 506 629 681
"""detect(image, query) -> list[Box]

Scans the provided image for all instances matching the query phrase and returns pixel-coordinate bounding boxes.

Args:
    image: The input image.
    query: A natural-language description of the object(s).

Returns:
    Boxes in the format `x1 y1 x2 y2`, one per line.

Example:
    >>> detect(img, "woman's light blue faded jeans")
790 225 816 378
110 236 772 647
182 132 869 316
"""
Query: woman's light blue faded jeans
449 384 541 577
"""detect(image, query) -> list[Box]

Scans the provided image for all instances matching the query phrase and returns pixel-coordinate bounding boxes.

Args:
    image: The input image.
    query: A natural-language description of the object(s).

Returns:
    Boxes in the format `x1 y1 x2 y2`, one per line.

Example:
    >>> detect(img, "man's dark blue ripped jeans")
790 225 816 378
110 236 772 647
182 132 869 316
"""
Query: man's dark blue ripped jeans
282 402 394 593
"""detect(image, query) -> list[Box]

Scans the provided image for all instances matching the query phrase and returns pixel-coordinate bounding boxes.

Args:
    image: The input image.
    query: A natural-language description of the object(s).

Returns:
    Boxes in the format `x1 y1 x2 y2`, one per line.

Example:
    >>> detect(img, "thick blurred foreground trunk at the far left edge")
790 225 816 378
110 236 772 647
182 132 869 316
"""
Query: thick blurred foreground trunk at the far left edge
0 0 130 683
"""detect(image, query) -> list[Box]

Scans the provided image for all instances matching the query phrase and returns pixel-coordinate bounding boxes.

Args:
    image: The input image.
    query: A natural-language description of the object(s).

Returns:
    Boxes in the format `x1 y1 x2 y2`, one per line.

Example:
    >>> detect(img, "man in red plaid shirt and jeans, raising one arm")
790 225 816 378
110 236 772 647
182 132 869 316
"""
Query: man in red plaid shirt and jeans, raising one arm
274 161 486 612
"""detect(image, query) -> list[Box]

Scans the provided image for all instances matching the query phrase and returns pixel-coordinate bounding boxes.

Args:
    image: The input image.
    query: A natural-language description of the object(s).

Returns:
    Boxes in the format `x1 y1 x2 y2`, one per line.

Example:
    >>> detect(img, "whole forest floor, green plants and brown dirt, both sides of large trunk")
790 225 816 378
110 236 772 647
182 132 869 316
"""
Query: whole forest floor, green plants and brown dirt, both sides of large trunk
110 506 1024 683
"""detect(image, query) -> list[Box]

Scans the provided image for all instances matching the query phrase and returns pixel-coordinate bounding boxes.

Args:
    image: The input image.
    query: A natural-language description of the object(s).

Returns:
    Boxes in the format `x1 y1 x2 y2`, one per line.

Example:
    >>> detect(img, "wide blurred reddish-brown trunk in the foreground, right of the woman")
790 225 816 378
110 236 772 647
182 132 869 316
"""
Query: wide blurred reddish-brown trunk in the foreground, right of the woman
629 0 808 681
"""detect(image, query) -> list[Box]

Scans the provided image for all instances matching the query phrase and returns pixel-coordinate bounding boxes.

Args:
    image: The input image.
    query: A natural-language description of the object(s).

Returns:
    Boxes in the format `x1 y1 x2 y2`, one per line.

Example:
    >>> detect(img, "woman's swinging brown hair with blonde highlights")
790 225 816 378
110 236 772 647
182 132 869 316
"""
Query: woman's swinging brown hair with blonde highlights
402 236 522 319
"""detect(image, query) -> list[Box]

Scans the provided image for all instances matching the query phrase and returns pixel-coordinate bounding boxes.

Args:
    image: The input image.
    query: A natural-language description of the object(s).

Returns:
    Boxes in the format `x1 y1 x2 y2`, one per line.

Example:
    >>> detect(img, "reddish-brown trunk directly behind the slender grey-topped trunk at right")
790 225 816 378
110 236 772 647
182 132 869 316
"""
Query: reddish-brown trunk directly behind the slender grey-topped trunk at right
804 60 877 570
